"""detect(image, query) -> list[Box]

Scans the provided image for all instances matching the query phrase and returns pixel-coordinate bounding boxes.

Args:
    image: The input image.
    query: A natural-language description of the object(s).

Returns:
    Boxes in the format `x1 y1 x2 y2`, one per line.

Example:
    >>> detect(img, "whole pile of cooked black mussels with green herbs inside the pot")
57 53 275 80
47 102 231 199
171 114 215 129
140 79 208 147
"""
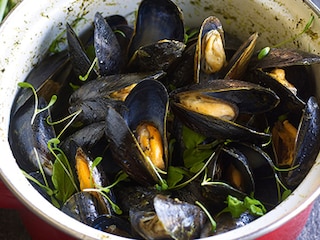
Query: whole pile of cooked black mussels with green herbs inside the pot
9 0 320 239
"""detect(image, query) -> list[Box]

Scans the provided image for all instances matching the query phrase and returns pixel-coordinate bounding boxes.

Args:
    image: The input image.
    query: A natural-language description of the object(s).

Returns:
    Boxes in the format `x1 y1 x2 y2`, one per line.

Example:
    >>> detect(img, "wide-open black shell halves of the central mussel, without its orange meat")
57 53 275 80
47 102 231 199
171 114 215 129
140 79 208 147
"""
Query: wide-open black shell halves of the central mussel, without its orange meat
105 80 168 185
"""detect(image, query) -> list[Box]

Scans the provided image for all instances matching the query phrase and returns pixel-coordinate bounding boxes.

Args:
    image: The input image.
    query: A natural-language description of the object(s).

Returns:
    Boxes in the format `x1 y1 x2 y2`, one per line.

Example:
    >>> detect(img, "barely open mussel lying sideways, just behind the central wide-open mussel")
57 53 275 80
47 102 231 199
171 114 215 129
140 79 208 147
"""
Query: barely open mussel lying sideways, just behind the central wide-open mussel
69 71 165 125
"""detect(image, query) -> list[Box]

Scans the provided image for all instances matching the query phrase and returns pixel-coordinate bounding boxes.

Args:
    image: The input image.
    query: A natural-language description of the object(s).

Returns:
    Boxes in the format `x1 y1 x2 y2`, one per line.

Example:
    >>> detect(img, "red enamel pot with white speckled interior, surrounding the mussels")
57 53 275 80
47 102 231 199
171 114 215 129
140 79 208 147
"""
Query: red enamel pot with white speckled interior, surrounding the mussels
0 0 320 240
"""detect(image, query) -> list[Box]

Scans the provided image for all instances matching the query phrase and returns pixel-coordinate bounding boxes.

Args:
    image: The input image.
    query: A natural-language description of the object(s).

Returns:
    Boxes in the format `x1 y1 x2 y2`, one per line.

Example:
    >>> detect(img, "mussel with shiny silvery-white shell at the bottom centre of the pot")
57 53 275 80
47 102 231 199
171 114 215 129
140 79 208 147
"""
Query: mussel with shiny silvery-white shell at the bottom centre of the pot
130 194 207 239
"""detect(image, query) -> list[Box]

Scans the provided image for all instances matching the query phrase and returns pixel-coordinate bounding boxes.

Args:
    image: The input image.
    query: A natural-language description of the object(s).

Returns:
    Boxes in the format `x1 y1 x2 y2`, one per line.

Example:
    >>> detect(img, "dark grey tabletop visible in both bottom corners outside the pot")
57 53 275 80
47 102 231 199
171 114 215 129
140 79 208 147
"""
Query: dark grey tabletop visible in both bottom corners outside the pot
0 197 320 240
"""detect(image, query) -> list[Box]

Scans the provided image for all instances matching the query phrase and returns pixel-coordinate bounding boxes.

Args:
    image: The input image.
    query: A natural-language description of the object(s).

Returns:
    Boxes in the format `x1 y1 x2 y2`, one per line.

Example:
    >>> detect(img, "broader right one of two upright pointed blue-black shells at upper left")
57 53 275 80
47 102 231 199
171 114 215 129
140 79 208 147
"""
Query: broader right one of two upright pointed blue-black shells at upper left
94 12 125 76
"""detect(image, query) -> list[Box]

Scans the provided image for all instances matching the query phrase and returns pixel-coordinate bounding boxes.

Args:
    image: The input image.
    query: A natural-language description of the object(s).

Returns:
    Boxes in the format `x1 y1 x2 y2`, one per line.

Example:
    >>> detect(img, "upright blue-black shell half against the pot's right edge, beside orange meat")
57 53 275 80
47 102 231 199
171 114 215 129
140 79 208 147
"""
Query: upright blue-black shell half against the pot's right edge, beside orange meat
287 97 320 188
